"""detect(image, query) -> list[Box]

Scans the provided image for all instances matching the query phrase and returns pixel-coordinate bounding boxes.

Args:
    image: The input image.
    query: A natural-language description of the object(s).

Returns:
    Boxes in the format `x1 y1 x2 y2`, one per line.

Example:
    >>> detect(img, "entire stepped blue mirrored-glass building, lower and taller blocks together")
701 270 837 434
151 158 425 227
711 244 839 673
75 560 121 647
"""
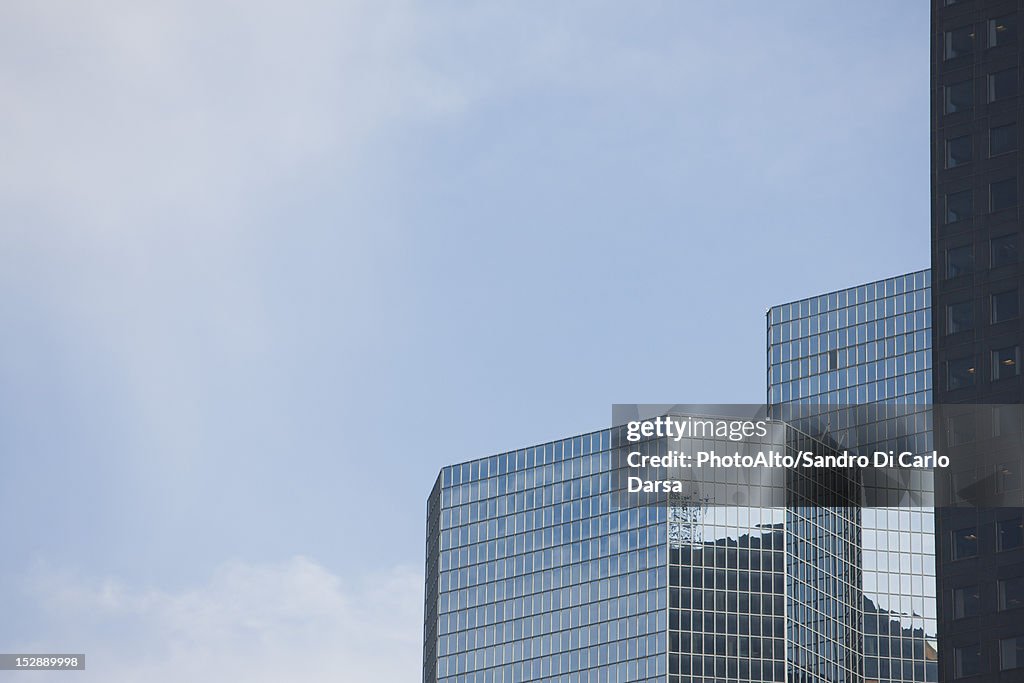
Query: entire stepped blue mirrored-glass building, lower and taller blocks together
423 271 937 683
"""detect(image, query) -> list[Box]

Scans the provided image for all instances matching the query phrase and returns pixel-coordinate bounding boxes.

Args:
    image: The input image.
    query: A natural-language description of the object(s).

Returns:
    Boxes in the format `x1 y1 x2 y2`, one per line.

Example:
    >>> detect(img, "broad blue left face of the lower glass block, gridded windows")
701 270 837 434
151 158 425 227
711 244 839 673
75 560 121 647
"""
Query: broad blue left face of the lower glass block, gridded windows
425 430 668 683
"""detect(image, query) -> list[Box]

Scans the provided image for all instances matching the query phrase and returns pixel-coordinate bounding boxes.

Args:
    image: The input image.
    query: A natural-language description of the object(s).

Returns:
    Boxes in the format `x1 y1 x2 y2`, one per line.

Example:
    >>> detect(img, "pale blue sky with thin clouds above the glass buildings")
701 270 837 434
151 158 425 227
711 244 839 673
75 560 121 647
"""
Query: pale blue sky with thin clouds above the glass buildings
0 0 930 683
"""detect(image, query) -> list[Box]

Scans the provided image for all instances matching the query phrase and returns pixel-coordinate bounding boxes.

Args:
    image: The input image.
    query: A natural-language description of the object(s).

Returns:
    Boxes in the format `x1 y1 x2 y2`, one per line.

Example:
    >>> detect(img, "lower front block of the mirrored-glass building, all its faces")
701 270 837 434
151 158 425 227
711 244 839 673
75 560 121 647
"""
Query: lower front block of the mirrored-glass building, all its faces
423 417 862 683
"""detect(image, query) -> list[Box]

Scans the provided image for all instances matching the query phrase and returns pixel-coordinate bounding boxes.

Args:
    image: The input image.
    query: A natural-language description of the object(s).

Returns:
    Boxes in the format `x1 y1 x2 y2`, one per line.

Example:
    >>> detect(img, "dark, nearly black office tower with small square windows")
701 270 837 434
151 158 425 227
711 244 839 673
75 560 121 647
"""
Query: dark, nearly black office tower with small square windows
931 0 1024 683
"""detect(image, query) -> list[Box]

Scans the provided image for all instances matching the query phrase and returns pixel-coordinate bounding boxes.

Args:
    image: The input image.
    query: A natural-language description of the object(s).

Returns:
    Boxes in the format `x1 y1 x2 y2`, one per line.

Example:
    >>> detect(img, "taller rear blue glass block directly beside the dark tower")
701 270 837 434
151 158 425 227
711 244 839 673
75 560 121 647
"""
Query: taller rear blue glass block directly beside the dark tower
767 270 938 682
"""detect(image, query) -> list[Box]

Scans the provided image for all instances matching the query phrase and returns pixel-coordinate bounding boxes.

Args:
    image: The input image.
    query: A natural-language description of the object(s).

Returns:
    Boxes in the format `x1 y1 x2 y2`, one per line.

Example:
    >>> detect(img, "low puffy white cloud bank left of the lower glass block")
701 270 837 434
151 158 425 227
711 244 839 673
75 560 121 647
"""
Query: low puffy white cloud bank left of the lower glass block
23 557 423 683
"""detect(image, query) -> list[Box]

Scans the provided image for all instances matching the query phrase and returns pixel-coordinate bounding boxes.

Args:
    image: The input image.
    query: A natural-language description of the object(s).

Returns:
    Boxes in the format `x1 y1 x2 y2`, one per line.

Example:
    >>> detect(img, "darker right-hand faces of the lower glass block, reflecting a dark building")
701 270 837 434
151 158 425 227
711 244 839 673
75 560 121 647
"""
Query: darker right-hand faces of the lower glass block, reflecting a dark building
669 426 861 683
